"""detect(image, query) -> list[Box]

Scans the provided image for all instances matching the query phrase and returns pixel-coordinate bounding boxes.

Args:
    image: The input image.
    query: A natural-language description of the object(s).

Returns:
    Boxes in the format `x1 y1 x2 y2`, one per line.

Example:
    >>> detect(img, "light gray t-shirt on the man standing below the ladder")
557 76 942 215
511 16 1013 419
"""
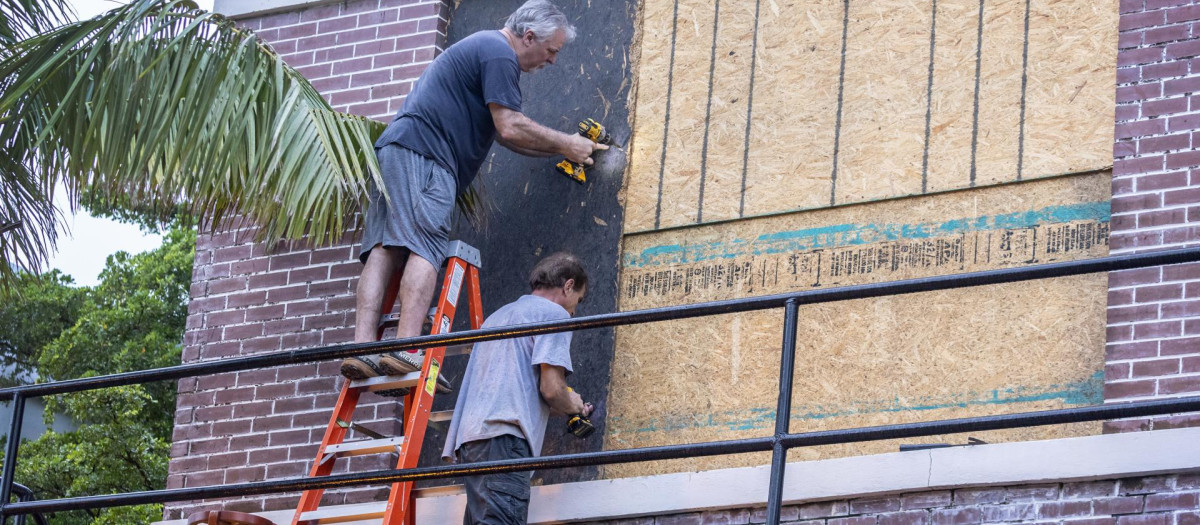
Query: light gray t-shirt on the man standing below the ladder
442 295 572 460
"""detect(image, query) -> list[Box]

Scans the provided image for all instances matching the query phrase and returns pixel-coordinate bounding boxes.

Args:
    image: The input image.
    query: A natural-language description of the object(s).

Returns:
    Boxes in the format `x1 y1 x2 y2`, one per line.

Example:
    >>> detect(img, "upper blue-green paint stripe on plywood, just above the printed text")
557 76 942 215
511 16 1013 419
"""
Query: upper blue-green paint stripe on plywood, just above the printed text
623 201 1112 267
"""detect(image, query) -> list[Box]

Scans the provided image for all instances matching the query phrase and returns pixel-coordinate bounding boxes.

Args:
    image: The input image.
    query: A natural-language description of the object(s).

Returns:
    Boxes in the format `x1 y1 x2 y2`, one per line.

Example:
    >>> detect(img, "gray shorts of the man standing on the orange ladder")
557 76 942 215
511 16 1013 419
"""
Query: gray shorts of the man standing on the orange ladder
359 144 457 268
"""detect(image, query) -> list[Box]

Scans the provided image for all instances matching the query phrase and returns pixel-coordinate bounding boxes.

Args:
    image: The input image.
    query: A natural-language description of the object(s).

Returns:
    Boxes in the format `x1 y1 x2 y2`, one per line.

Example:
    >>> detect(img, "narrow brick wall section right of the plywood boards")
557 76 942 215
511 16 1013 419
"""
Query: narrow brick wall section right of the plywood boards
1104 0 1200 432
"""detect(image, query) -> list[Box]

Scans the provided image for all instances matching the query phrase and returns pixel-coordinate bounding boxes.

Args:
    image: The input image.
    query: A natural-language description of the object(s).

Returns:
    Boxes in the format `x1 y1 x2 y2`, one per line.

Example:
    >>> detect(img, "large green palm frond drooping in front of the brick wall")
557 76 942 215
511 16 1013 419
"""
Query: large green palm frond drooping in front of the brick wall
0 0 398 282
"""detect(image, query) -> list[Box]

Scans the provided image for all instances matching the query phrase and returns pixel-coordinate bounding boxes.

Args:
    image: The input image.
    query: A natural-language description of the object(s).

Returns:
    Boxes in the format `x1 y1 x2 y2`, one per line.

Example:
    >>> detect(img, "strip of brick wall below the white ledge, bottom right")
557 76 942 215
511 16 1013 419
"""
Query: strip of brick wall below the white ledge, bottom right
588 473 1200 525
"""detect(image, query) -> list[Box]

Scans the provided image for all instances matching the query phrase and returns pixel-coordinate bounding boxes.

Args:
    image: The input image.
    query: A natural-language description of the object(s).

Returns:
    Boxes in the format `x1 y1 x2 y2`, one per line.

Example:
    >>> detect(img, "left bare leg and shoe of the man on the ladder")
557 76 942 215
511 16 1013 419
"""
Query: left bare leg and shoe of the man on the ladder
342 245 407 379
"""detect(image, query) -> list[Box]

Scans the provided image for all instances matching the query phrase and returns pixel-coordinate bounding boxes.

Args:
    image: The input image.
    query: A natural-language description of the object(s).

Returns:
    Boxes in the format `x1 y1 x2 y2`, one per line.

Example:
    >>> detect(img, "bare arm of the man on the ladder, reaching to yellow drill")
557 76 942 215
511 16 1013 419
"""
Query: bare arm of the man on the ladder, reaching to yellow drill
487 103 608 165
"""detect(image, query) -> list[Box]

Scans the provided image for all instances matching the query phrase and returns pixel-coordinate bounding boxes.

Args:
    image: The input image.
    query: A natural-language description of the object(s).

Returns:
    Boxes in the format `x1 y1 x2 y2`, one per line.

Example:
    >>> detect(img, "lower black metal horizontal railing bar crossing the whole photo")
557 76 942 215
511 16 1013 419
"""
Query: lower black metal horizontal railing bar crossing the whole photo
0 396 1200 515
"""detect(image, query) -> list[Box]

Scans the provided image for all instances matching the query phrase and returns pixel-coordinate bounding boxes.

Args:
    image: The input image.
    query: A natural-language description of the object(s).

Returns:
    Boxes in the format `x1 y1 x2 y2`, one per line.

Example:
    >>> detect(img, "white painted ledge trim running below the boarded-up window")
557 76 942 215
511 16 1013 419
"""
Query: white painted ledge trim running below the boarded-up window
160 428 1200 525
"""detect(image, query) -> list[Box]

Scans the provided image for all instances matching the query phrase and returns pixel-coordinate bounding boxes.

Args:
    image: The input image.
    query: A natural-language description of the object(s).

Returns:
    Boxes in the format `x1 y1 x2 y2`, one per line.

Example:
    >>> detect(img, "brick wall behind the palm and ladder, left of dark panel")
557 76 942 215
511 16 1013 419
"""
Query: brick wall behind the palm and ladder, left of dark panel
166 0 449 519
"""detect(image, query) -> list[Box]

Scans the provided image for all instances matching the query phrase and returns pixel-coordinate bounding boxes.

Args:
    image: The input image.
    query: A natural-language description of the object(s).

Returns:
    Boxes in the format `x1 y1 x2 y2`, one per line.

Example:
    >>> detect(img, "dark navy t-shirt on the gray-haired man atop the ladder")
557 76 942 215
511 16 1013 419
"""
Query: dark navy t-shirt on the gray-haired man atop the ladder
376 31 521 193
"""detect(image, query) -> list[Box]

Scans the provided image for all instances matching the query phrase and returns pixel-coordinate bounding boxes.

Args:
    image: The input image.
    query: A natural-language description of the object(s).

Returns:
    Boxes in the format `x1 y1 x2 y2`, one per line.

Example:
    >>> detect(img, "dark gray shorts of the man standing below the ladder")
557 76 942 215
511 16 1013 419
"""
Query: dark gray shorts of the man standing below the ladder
458 434 533 525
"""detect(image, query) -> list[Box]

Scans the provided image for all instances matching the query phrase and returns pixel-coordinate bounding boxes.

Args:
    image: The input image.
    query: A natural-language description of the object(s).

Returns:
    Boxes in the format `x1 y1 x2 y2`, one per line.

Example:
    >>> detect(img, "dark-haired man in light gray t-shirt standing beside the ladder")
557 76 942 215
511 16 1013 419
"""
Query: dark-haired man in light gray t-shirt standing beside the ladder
442 252 592 524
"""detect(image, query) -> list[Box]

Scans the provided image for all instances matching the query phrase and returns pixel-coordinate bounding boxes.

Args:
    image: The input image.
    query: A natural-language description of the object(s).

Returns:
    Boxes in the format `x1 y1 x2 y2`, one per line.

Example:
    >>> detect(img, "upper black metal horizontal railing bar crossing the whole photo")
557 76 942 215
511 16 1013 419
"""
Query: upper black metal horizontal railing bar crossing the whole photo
0 248 1200 400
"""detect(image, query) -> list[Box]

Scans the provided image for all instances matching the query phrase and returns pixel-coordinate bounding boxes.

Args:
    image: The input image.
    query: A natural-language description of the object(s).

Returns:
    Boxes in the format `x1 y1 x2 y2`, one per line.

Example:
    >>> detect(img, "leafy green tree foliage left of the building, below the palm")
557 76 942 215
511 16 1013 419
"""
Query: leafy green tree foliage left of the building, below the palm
0 228 196 525
